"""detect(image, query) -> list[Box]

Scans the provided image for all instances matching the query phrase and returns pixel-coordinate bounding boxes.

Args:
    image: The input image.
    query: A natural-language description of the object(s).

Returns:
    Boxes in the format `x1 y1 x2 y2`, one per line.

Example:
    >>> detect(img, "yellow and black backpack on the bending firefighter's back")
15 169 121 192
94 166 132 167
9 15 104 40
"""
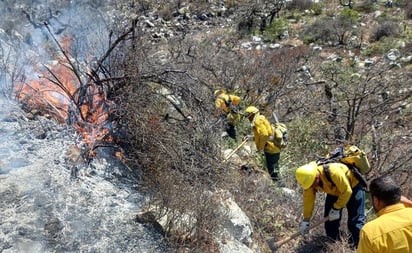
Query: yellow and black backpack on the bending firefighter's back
316 145 370 188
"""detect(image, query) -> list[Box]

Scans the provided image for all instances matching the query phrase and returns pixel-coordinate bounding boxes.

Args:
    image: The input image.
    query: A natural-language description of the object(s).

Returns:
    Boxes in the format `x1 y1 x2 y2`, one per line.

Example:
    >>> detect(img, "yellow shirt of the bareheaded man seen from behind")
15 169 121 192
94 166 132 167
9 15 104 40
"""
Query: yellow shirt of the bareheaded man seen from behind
356 203 412 253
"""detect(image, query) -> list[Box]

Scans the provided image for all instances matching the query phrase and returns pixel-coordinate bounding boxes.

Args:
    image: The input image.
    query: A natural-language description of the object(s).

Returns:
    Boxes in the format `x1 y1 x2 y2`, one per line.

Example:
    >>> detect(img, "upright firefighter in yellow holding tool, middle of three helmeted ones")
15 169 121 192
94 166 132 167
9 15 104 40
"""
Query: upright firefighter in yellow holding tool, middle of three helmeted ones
245 106 282 181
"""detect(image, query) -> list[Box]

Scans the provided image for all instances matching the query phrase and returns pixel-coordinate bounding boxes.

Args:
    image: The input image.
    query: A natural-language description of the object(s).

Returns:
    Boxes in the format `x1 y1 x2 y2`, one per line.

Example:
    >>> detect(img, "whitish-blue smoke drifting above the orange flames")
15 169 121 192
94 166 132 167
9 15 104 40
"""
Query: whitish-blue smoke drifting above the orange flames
0 0 113 94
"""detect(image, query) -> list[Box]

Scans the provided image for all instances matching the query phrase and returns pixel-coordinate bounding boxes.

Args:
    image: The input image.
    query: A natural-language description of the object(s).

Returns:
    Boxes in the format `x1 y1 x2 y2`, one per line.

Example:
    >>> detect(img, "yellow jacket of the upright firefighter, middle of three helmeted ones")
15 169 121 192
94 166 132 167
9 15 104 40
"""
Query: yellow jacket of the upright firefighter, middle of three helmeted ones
252 113 280 154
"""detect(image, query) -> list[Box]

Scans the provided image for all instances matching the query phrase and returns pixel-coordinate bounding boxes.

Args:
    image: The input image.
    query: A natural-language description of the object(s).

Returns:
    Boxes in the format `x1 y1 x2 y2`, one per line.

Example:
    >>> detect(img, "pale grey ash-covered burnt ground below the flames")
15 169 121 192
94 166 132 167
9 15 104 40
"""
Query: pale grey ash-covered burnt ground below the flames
0 98 166 253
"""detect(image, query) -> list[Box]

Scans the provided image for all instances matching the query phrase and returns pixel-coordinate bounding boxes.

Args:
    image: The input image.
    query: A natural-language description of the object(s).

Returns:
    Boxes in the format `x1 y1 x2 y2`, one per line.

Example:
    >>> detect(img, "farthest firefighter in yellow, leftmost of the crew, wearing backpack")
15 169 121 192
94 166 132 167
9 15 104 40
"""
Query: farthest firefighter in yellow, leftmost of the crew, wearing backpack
214 89 240 139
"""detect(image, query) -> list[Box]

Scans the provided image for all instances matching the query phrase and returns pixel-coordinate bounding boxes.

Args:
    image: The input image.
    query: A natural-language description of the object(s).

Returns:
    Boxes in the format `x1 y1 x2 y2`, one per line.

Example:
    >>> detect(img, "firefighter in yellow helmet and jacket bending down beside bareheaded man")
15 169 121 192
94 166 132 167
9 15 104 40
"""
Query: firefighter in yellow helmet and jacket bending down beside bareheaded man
295 161 365 247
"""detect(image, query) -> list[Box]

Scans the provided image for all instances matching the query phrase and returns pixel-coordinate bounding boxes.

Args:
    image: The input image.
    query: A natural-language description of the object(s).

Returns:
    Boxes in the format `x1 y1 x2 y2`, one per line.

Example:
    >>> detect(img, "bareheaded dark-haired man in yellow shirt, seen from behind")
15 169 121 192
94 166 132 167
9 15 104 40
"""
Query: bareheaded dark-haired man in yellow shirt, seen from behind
357 176 412 253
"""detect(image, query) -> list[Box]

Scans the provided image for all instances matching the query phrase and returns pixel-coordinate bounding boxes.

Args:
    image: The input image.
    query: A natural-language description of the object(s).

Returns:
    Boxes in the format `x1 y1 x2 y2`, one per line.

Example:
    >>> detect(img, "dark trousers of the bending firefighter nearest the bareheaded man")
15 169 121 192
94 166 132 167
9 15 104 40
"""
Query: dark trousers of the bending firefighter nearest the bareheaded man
324 184 365 247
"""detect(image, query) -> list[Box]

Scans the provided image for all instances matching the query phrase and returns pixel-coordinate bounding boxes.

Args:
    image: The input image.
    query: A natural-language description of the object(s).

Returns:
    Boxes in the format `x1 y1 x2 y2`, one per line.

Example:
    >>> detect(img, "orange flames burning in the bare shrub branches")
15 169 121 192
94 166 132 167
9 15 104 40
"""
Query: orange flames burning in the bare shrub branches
15 33 113 147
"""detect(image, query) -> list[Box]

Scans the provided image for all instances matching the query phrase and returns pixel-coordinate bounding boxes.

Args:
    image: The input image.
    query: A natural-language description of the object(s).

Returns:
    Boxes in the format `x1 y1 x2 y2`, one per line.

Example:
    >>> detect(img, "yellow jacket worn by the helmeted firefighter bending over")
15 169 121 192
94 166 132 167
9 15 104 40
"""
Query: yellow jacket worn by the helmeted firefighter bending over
303 163 359 220
